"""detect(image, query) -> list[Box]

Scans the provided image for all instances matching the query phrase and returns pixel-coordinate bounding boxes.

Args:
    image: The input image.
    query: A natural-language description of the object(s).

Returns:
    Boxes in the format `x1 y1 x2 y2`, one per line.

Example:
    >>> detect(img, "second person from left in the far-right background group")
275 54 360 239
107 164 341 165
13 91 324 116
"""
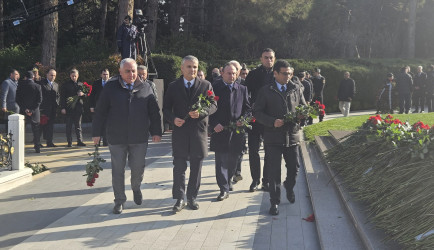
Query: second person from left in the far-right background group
396 66 413 114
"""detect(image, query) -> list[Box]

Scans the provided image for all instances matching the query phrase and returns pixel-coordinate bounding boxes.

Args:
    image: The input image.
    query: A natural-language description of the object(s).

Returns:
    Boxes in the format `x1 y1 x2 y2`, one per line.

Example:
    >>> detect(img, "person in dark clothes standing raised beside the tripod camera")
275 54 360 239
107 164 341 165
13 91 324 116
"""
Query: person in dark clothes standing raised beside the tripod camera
116 16 137 60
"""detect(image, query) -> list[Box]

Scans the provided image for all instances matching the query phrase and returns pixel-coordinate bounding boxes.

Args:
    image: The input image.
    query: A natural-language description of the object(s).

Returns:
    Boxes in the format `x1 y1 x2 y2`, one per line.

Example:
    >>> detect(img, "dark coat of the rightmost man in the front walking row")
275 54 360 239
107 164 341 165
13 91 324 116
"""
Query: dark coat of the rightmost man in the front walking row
253 81 306 146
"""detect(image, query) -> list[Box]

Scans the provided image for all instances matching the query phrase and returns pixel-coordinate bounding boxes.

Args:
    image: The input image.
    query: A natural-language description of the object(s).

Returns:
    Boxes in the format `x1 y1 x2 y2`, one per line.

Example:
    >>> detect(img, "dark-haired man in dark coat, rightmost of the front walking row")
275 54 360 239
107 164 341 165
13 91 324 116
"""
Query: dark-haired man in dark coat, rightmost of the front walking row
253 60 306 215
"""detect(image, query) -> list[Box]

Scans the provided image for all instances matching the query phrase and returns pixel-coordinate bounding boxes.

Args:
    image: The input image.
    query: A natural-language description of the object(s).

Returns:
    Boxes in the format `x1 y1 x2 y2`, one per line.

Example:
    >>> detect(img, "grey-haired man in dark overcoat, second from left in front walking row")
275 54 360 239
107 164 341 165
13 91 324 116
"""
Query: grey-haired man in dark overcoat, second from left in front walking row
163 56 217 212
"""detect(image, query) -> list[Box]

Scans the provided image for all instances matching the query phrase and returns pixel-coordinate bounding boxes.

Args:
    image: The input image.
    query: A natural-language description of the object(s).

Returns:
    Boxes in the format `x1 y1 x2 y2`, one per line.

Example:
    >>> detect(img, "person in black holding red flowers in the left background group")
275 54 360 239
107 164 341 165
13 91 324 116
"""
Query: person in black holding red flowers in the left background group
60 69 86 147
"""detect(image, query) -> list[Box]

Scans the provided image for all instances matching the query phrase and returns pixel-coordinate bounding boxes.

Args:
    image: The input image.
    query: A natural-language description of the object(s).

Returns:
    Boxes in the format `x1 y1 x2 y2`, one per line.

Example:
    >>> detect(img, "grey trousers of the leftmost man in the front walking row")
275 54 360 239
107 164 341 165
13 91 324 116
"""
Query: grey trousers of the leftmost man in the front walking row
109 142 148 204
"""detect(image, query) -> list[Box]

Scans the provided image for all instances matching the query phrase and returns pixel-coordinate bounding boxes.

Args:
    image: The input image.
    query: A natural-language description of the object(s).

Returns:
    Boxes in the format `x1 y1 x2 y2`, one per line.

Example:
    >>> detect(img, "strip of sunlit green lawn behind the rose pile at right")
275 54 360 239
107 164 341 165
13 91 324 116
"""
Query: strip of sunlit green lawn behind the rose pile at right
303 113 434 141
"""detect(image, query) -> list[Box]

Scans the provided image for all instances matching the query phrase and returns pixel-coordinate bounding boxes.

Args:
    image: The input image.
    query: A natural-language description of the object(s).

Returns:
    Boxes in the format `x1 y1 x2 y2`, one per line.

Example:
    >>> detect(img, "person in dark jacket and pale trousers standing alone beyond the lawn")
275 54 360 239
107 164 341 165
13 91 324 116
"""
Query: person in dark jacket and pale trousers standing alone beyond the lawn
338 71 356 117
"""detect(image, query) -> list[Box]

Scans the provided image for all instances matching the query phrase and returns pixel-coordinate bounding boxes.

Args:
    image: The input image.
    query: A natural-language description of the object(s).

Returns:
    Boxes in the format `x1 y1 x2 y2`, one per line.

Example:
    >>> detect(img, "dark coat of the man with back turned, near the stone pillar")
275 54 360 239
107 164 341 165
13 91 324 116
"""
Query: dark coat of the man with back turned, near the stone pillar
16 79 42 123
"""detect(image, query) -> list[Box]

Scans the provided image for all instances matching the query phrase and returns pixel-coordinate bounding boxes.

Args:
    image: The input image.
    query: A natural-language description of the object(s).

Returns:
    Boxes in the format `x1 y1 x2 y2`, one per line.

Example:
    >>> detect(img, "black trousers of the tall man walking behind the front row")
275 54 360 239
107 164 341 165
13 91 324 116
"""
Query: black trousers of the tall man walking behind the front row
248 131 268 184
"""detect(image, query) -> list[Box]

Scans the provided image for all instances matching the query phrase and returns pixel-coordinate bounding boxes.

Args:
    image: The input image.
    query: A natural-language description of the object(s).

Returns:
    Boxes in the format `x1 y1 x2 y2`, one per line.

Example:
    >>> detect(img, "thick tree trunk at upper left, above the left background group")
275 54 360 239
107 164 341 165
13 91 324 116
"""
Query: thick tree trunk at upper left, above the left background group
41 0 59 68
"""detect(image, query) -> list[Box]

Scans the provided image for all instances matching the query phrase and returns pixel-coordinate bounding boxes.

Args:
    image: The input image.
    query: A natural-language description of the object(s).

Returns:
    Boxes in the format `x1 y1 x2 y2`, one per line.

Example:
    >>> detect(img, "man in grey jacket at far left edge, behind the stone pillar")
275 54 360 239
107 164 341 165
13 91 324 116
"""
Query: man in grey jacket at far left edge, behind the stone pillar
0 69 20 131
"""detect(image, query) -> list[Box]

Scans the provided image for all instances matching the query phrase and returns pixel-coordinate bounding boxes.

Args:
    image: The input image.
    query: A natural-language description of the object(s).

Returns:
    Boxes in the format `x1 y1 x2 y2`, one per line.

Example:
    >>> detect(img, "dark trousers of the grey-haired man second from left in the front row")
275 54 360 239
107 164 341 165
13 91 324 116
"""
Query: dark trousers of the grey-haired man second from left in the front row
172 157 203 200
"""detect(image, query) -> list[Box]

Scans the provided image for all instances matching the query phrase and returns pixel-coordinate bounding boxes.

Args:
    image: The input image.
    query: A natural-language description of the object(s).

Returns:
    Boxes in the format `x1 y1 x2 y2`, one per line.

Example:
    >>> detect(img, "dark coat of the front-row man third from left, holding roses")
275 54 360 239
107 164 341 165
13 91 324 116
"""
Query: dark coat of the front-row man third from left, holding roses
209 80 251 153
